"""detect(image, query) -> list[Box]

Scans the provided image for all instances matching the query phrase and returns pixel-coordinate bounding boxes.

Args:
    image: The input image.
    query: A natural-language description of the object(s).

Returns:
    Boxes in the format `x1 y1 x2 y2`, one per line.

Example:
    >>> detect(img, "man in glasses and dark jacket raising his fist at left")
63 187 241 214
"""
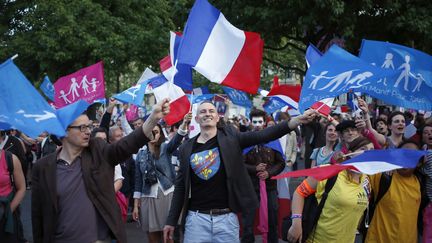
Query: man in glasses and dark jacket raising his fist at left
32 99 169 243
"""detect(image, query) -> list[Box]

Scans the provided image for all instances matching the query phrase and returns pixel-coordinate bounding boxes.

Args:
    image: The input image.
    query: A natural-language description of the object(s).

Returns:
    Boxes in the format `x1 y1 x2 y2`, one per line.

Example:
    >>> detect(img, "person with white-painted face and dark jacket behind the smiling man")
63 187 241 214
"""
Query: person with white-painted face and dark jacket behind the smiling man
242 109 285 243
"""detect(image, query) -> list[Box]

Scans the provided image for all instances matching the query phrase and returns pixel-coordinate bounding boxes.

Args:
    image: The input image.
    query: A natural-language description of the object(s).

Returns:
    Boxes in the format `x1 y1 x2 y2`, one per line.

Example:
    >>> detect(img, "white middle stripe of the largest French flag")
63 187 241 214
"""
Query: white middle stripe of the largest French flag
195 14 246 84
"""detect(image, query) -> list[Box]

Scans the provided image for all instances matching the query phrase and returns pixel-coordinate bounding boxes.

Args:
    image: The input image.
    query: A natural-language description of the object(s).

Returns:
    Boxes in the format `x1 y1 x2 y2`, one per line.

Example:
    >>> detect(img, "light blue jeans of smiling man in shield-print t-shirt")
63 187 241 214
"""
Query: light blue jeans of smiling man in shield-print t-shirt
184 211 240 243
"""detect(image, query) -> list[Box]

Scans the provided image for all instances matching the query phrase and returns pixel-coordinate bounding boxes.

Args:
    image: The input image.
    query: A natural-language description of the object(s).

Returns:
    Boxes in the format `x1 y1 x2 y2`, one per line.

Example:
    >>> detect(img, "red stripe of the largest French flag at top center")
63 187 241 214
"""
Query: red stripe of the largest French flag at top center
222 31 264 94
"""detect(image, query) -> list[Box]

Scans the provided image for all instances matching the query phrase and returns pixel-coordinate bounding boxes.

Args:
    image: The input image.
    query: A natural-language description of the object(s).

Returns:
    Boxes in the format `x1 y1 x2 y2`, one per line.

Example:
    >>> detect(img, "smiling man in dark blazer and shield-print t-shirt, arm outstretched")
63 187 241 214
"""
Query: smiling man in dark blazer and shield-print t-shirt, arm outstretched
164 102 315 242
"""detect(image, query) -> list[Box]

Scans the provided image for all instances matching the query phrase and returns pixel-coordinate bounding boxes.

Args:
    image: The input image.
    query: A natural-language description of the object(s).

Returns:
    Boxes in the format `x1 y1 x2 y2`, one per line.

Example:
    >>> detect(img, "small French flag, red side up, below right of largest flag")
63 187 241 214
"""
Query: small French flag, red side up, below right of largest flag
267 76 301 110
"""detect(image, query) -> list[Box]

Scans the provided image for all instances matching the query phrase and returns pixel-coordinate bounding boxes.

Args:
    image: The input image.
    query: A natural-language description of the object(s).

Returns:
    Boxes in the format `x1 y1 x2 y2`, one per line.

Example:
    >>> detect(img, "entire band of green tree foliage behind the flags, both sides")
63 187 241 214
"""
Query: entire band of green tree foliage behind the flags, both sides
0 0 432 93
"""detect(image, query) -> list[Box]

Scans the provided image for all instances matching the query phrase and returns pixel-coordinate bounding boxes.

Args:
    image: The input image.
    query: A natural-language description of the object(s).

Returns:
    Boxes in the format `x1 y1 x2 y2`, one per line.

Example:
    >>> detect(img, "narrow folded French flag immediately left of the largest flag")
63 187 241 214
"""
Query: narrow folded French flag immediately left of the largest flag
159 31 192 91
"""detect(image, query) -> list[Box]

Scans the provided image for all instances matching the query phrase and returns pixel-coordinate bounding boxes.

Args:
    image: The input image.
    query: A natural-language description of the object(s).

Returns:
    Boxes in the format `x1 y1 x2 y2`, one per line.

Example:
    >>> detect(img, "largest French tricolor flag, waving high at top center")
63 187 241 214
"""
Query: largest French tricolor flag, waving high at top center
178 0 264 94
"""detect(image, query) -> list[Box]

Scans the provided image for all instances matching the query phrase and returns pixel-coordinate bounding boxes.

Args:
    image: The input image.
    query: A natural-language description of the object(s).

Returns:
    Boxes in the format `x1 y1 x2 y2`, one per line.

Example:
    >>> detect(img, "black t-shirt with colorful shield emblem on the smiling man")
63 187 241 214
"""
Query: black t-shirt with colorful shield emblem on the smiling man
189 137 229 210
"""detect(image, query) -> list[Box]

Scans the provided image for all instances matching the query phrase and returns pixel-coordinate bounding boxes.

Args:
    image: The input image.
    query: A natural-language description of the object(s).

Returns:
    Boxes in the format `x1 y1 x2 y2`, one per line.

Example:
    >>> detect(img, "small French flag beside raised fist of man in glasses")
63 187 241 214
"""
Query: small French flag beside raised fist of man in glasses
149 75 190 125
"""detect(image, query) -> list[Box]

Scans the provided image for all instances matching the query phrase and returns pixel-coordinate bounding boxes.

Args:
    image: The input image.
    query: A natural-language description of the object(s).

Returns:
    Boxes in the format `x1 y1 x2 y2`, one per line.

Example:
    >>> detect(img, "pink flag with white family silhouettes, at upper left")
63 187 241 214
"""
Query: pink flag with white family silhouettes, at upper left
54 62 105 108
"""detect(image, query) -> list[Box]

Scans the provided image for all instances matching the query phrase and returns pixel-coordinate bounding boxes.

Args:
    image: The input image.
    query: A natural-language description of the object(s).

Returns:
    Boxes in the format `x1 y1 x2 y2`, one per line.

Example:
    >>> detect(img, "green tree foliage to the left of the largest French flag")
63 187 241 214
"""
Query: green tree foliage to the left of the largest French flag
0 0 173 93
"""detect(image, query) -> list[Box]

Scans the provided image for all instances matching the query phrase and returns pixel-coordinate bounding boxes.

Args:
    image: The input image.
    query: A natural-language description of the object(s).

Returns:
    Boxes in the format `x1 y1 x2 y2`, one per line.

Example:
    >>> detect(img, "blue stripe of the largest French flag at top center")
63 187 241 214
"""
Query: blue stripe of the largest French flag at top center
178 0 221 66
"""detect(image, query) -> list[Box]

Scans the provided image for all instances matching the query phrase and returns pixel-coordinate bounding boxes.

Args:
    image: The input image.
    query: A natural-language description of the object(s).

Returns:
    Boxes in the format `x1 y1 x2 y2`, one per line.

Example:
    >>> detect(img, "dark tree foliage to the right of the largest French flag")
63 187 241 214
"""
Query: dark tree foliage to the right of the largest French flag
169 0 432 89
